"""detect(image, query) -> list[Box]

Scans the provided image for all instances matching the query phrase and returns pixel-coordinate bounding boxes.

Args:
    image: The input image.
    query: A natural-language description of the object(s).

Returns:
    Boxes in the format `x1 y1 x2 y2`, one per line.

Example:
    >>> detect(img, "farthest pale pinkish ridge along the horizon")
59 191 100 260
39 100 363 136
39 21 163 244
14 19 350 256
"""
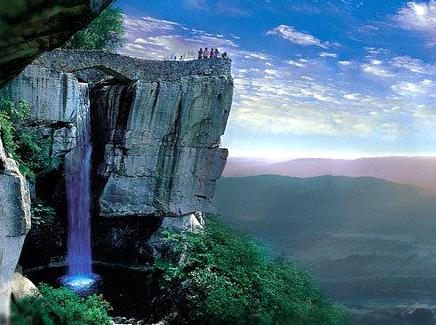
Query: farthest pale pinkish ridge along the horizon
224 157 436 188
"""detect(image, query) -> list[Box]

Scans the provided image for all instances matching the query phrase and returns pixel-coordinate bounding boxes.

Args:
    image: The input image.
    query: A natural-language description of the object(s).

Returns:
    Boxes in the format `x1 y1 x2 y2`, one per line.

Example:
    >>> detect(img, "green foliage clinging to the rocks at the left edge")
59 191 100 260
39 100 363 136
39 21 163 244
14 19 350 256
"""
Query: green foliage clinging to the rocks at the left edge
0 98 54 179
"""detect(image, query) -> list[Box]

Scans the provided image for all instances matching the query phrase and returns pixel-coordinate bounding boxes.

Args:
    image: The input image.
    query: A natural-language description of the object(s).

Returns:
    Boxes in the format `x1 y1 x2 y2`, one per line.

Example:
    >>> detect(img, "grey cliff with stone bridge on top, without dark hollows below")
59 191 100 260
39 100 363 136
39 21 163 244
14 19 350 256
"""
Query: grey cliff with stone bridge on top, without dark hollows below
3 51 233 217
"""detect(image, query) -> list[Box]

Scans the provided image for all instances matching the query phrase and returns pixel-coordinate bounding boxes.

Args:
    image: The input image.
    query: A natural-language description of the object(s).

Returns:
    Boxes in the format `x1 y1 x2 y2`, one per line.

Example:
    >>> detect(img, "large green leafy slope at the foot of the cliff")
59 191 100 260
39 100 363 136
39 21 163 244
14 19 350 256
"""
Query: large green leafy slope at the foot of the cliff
154 220 345 325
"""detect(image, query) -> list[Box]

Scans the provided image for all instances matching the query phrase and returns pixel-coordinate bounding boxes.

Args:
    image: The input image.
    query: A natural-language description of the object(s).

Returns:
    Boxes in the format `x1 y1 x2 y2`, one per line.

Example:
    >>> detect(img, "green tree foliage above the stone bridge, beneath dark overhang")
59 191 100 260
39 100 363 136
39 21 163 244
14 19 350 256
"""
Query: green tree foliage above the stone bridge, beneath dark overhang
63 8 125 51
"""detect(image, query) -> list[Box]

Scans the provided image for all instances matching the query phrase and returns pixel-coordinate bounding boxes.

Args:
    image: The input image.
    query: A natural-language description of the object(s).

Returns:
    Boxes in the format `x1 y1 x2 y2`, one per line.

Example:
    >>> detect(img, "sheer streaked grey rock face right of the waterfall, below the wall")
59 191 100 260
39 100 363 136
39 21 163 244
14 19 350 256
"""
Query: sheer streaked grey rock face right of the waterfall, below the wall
91 76 233 217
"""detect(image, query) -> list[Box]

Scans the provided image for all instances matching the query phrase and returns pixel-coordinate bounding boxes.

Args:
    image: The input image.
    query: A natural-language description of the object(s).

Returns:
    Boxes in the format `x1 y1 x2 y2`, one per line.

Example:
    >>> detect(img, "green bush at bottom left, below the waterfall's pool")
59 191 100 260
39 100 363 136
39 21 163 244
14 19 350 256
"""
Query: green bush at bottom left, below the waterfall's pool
11 285 112 325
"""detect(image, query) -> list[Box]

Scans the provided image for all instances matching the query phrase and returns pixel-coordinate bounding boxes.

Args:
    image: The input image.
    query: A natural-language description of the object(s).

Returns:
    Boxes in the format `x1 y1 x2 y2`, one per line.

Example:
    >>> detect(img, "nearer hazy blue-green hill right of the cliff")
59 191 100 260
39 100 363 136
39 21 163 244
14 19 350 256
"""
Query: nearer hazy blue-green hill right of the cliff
214 175 436 303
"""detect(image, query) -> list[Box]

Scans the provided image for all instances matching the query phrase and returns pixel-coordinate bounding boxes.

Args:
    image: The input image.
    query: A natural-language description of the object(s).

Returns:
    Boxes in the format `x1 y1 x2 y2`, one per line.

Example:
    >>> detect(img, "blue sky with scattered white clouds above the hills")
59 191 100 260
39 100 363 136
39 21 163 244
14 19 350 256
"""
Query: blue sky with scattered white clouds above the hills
116 0 436 159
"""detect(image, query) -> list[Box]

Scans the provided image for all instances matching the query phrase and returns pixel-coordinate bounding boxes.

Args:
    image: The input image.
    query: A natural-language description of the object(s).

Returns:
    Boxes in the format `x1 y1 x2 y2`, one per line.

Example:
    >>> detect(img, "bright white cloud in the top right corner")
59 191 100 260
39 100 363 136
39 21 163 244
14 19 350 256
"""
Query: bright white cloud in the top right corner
394 0 436 45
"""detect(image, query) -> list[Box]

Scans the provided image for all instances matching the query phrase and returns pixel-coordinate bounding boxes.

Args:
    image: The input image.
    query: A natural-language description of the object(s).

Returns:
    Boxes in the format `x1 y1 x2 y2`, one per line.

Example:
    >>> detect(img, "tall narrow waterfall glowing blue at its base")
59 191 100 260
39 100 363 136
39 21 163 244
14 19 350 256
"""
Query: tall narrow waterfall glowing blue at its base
61 84 98 292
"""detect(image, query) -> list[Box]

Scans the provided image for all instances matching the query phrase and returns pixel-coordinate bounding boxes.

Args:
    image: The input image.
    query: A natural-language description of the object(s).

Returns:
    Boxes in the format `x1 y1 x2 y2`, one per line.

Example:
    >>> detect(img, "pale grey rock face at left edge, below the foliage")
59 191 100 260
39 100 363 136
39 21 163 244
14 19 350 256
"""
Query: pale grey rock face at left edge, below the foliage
0 140 30 323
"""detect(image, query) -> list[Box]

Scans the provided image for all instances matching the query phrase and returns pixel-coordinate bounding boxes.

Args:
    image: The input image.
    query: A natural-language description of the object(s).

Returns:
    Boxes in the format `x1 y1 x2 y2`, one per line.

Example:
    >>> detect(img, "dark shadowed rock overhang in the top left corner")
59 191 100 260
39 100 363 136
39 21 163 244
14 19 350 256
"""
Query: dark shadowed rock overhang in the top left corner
0 0 112 88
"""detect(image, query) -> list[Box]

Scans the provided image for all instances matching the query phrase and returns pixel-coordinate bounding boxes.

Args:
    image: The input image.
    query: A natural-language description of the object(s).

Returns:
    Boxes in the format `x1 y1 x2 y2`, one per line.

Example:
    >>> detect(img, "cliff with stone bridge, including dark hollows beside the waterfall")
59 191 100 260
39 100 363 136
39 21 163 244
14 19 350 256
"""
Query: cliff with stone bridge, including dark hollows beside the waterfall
0 50 233 268
